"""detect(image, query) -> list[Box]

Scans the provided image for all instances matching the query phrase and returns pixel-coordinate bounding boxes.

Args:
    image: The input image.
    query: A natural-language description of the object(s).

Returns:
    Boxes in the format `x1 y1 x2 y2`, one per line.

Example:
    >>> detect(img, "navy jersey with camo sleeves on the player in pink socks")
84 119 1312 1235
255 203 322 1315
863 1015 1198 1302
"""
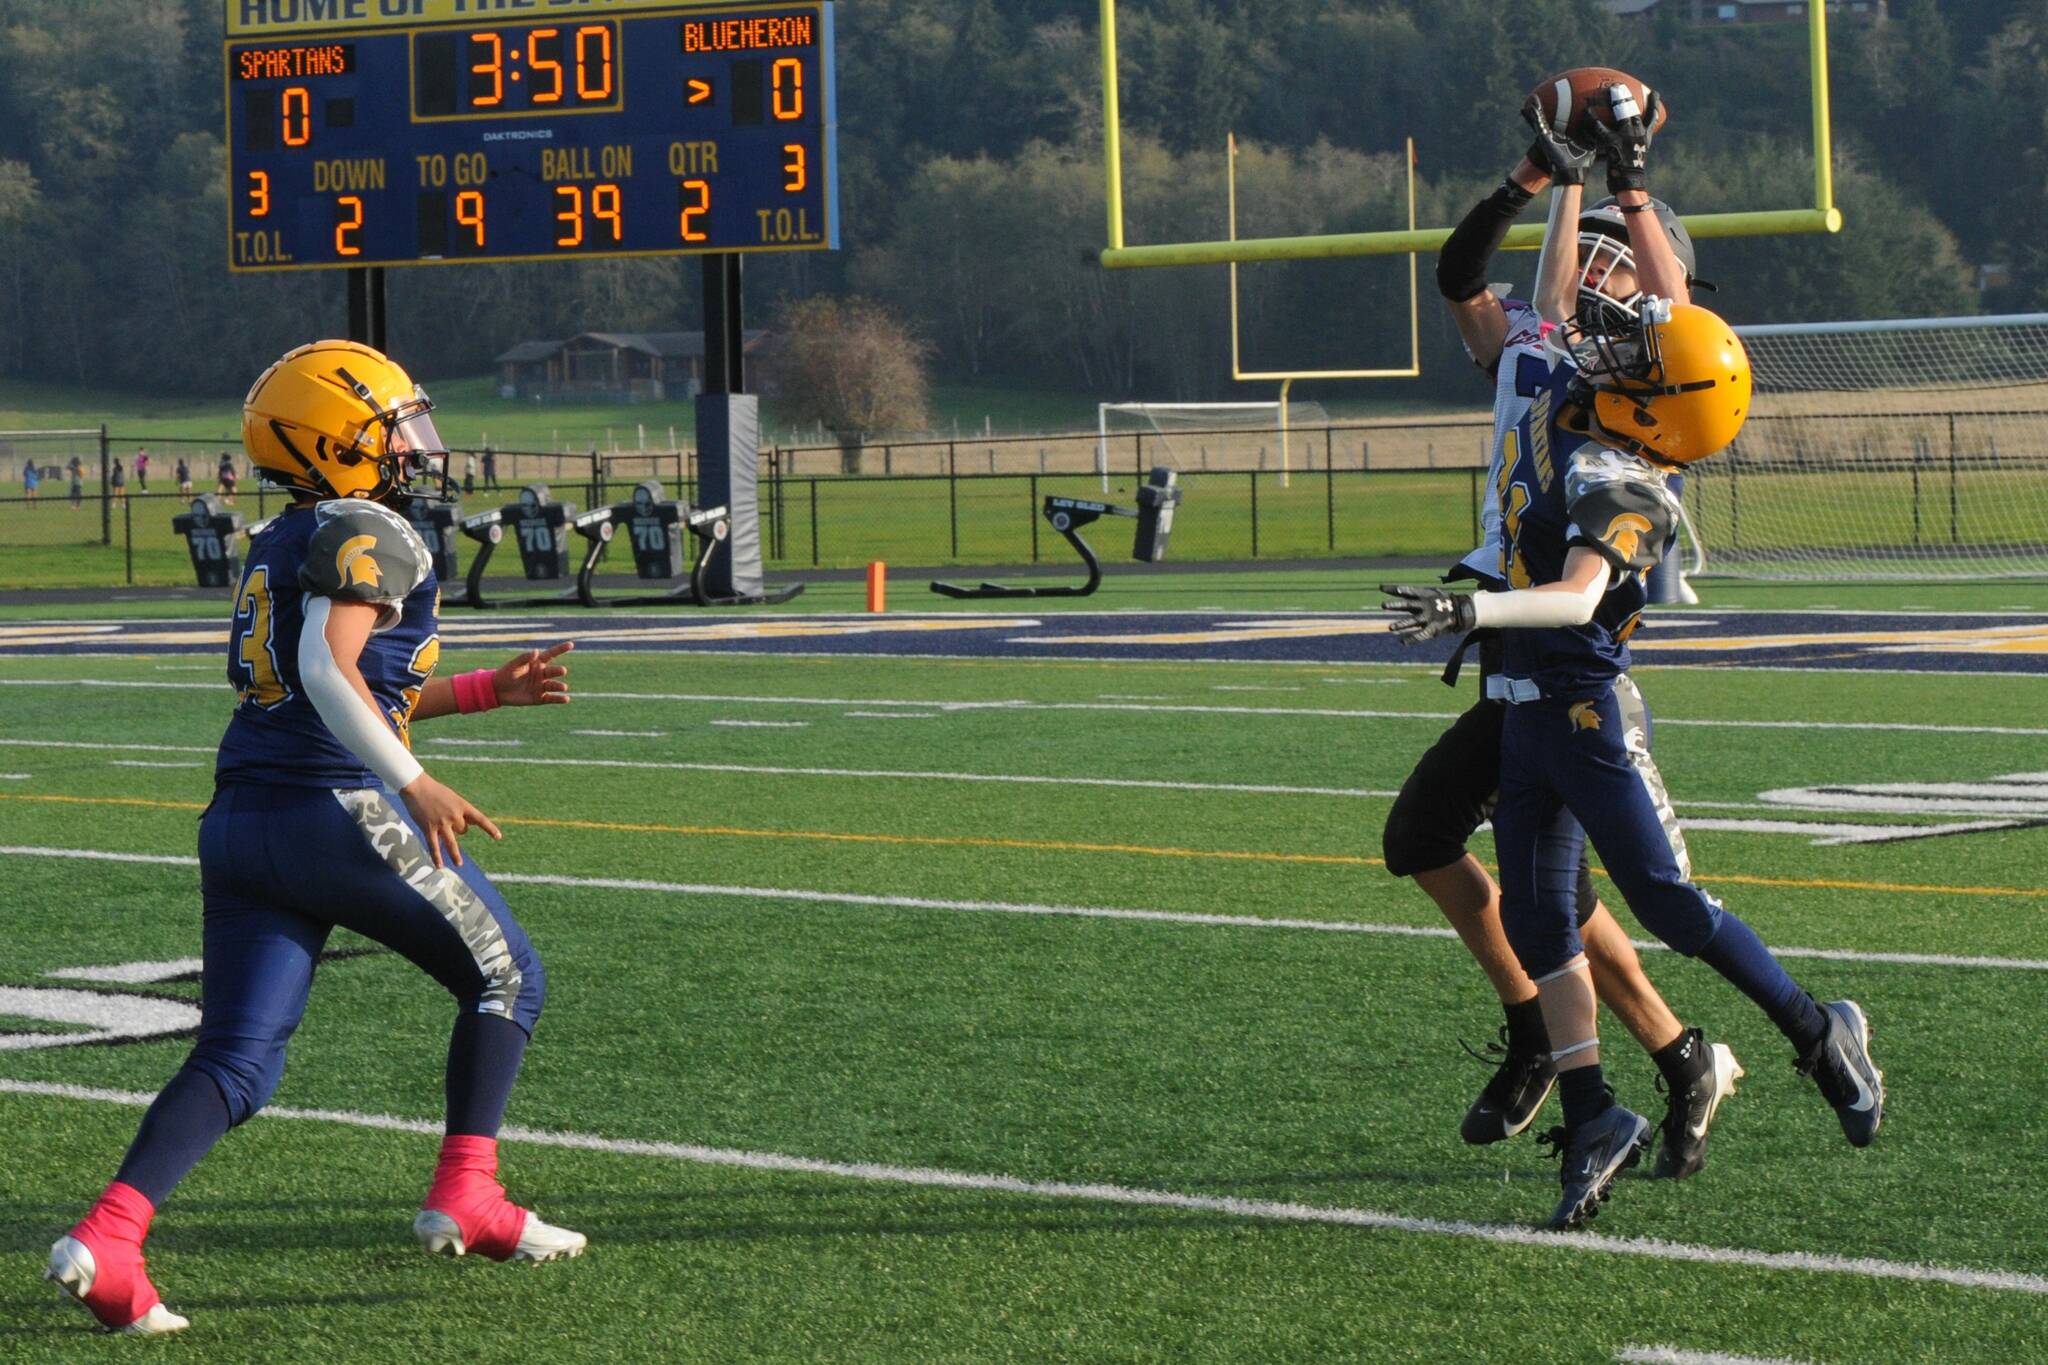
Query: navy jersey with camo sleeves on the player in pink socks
213 499 440 788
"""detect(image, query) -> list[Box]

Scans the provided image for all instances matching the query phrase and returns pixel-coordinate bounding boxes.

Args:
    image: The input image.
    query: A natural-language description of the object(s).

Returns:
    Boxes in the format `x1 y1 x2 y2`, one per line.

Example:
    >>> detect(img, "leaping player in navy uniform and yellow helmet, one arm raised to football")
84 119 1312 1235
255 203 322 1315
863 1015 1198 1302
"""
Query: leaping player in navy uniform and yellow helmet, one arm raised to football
1386 86 1884 1228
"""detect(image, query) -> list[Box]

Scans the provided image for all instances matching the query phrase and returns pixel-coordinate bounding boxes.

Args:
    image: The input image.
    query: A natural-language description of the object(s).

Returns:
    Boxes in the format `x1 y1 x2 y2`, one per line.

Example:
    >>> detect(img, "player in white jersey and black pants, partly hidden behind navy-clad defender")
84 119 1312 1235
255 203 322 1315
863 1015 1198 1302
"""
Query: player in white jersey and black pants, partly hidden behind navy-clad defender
1382 80 1743 1179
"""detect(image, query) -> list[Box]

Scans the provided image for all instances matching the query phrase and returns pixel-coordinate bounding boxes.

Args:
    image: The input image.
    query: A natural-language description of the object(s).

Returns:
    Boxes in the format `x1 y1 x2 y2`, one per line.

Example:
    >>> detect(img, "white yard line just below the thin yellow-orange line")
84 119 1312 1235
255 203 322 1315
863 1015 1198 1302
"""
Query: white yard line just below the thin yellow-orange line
0 845 2048 972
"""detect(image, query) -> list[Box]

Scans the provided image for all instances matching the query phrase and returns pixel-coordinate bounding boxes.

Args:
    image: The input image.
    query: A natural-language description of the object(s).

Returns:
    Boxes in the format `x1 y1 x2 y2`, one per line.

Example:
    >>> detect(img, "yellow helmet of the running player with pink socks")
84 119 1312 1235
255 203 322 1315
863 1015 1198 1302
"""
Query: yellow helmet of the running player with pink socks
242 342 446 501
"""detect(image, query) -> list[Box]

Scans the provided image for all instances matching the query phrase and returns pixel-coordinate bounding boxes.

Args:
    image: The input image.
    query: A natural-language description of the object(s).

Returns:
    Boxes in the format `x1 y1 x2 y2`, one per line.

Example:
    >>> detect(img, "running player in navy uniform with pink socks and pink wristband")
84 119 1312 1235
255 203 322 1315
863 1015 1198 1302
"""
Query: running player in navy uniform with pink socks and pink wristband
45 342 584 1334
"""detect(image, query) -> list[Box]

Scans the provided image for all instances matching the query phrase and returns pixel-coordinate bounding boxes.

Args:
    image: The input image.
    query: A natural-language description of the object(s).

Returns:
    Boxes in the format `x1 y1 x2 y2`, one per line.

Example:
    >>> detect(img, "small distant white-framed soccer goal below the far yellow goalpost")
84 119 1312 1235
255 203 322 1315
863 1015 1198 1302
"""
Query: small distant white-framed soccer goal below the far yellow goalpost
1096 403 1329 487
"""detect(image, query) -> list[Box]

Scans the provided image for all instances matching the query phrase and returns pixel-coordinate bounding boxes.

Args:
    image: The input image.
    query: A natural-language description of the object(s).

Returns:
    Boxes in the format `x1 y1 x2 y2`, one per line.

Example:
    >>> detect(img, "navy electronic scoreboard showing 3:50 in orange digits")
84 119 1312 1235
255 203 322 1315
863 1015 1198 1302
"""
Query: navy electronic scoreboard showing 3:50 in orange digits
227 0 840 270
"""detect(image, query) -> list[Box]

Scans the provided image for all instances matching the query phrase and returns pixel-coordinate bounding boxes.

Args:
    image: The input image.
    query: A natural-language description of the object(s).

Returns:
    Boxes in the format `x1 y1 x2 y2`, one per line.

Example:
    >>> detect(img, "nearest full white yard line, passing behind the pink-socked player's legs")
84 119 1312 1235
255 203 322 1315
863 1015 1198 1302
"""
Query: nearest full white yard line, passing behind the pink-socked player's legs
0 1081 2048 1295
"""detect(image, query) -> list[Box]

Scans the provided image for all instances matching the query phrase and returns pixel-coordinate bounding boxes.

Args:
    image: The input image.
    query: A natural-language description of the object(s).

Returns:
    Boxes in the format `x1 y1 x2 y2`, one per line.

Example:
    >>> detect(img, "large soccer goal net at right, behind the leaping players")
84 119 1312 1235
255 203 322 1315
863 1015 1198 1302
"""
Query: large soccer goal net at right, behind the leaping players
1686 313 2048 581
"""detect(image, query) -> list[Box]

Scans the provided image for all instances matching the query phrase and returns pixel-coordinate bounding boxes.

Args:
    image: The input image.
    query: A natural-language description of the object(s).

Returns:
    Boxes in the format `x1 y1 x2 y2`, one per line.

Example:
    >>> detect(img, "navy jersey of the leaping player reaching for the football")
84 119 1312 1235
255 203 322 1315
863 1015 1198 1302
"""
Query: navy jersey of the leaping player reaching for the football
1495 346 1677 700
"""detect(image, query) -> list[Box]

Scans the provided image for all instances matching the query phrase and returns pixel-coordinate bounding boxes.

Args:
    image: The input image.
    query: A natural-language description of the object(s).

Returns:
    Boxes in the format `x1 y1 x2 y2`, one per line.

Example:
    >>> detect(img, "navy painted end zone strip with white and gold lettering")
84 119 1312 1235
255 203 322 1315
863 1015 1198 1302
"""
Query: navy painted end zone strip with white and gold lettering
0 612 2048 675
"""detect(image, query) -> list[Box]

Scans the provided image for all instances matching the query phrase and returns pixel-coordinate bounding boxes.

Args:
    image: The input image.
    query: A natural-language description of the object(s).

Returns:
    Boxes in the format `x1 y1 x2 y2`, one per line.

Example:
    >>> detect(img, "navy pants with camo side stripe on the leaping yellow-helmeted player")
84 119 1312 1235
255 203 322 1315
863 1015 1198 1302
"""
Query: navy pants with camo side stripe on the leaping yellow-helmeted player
1493 673 1726 976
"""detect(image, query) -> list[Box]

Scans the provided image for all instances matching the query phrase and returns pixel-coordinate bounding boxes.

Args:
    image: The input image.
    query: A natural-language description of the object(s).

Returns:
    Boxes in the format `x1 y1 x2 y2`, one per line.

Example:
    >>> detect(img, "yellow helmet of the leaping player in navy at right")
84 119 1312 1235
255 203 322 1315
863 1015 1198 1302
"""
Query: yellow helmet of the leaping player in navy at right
1573 299 1751 467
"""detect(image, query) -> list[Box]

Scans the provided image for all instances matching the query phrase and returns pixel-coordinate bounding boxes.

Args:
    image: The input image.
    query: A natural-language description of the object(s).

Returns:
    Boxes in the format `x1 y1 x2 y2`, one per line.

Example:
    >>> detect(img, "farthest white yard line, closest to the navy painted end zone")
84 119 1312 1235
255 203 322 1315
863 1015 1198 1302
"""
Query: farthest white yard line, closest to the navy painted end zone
0 675 2048 737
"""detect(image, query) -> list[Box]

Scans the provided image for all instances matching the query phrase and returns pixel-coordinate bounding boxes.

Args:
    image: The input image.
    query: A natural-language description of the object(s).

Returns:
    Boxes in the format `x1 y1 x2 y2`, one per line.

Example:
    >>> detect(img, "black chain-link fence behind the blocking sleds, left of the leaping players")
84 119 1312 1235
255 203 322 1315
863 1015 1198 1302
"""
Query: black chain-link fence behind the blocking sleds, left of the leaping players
0 420 1491 587
